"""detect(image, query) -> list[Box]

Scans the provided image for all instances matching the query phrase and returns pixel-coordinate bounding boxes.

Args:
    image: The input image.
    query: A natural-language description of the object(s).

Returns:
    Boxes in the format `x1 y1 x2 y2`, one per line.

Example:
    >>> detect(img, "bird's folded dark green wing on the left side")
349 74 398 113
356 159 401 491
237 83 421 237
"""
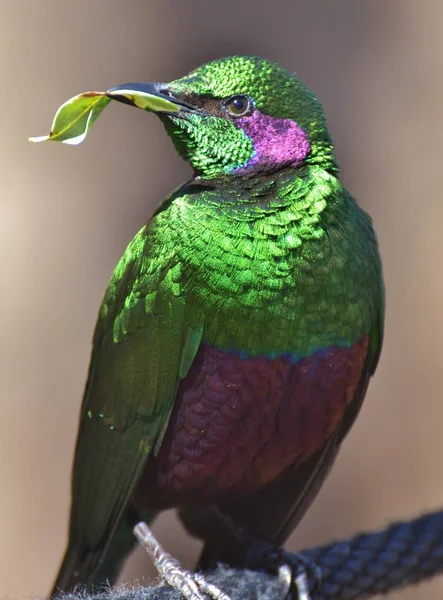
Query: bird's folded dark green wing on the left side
52 225 201 589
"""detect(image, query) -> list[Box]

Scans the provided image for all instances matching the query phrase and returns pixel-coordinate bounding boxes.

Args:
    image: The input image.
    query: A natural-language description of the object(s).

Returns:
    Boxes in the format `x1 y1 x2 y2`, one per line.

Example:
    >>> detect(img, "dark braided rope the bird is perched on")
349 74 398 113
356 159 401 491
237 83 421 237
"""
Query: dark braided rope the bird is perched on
59 510 443 600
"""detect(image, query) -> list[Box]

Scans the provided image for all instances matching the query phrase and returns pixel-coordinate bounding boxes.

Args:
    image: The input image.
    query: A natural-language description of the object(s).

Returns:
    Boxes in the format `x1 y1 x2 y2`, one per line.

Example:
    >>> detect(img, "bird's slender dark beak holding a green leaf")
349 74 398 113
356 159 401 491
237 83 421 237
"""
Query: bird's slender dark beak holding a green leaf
105 82 201 116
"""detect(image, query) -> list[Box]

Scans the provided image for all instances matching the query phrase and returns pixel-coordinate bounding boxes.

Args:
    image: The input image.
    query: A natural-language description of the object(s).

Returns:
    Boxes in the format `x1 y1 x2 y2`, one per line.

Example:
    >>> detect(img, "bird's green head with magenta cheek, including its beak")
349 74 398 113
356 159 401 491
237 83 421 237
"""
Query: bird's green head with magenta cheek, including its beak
109 56 336 178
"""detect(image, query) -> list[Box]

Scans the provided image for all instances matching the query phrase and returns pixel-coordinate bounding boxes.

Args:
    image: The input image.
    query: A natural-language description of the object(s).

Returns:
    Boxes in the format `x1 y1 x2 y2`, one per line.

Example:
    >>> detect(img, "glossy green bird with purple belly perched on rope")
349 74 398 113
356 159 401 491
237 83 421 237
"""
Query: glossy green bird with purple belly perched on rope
53 56 384 594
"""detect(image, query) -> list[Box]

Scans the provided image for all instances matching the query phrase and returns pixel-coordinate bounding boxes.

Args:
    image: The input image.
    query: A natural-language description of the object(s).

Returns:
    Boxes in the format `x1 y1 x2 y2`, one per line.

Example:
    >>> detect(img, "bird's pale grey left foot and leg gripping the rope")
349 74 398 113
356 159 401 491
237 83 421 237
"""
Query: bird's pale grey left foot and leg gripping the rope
133 521 230 600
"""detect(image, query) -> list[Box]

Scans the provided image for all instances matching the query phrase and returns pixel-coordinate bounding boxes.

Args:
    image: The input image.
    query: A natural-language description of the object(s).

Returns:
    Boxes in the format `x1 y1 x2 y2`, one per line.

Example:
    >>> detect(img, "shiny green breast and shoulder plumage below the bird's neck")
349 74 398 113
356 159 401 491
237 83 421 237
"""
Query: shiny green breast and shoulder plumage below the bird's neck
108 167 380 357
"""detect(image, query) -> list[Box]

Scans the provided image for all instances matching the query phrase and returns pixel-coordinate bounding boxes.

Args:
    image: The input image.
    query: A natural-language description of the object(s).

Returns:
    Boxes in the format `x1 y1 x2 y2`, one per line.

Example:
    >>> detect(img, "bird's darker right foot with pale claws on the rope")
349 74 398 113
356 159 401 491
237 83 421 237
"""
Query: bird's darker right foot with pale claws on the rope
246 540 322 600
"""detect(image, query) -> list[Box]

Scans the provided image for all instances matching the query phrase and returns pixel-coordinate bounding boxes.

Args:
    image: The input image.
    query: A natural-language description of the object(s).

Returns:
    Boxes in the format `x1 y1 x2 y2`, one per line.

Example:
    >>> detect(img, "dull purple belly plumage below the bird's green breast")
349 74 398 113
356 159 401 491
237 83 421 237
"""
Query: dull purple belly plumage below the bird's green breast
140 336 368 507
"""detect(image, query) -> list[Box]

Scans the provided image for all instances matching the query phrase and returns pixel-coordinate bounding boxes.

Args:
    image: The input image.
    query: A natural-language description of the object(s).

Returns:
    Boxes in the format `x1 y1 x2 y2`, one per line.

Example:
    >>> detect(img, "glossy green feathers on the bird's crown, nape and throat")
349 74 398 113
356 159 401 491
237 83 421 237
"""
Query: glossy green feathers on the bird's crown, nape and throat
166 56 338 177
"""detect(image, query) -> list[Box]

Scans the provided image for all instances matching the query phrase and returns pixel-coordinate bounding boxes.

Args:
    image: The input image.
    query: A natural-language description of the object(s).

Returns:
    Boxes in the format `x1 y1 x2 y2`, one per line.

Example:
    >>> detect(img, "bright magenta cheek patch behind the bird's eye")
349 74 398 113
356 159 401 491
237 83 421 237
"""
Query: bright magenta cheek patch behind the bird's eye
235 110 311 173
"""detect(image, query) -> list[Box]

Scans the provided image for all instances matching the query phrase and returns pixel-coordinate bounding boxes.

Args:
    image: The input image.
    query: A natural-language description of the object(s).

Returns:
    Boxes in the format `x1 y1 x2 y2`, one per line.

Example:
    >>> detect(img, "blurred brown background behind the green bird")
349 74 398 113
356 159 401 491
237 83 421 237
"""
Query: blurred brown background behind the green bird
0 0 443 600
